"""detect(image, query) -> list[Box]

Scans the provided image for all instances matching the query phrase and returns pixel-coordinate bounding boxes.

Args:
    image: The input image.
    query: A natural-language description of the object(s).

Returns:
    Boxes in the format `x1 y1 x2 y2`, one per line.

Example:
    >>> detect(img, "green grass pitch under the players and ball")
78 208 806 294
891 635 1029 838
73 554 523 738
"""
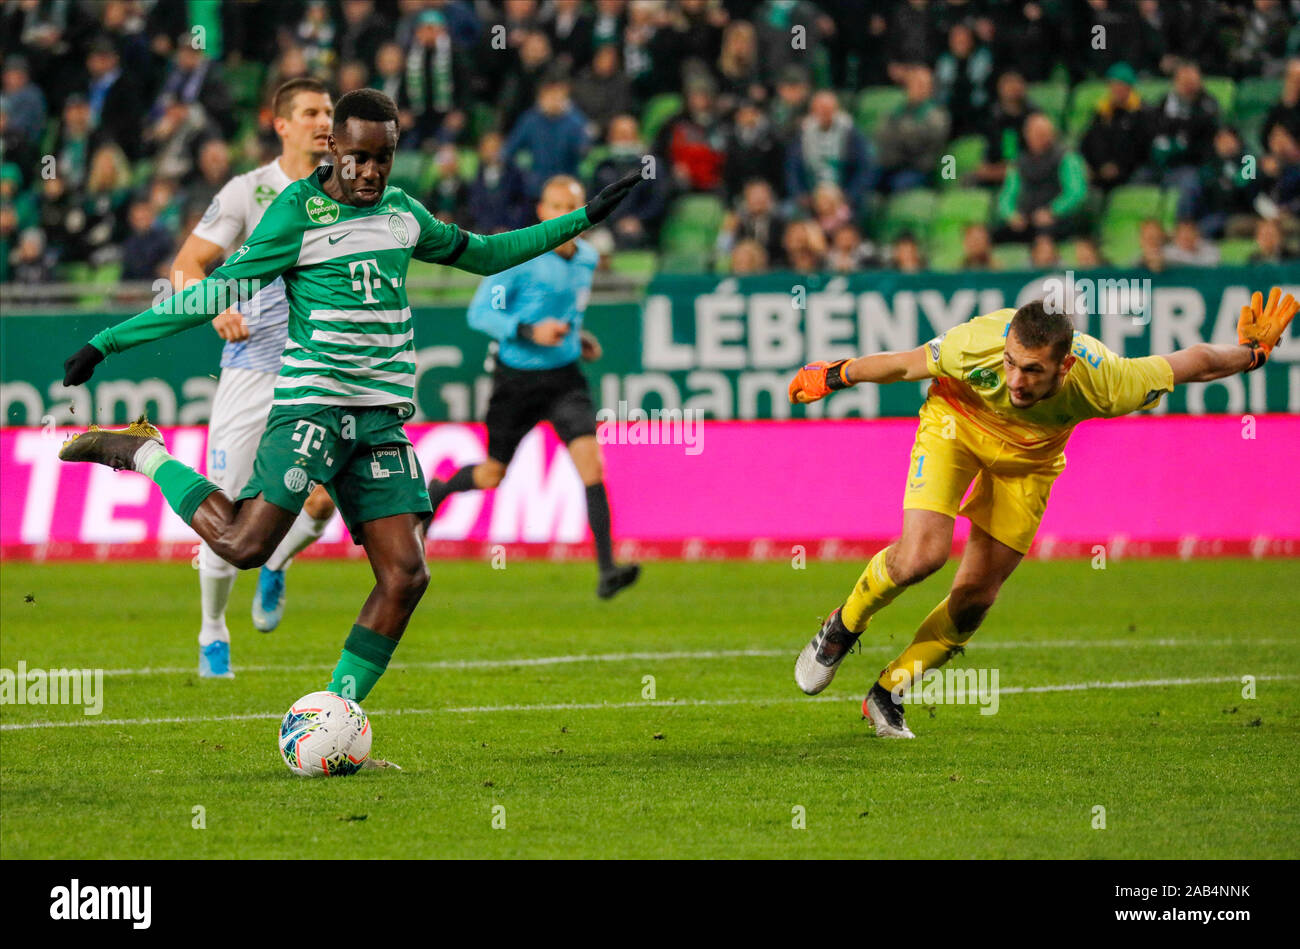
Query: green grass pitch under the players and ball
0 560 1300 859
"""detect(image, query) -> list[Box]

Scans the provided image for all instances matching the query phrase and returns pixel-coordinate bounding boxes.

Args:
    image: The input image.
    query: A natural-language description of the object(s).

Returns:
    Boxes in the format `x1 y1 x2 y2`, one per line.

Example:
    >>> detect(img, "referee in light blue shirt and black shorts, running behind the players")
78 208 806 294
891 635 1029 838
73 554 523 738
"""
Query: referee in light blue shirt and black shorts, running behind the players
429 174 641 598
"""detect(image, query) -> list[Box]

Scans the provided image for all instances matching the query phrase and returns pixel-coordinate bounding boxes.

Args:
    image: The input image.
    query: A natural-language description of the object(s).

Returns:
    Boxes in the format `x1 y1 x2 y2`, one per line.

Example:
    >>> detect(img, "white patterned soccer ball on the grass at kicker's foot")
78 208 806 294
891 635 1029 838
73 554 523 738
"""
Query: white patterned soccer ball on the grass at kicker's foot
280 692 373 777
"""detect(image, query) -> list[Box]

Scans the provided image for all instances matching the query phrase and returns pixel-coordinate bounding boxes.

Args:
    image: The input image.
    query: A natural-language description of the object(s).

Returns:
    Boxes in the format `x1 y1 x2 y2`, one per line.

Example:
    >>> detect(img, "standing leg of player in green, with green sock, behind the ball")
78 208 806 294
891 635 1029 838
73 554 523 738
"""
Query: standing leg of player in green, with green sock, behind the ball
329 514 429 702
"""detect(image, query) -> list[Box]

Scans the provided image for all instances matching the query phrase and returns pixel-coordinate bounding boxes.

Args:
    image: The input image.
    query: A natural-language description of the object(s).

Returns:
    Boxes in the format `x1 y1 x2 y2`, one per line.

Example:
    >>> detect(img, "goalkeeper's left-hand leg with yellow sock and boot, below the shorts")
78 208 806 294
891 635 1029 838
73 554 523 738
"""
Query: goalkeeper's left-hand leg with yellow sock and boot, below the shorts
794 510 953 696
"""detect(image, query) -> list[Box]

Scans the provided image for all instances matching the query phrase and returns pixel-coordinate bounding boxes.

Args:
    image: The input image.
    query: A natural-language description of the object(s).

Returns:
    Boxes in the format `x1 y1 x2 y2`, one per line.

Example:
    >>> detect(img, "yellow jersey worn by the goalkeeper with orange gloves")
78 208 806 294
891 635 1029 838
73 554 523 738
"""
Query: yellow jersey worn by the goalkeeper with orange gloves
926 308 1174 456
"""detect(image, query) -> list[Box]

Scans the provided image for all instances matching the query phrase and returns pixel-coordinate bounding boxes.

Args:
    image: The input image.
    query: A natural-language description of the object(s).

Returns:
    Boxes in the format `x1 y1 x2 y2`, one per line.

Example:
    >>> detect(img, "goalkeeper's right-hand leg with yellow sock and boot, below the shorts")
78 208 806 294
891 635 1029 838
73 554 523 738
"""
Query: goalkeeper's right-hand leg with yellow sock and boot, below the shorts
862 524 1024 738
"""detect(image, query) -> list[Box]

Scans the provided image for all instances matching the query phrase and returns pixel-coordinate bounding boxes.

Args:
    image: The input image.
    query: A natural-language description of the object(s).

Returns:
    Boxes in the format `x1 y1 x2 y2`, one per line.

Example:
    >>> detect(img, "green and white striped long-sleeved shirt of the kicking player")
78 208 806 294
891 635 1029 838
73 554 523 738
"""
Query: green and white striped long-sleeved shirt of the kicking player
91 168 590 415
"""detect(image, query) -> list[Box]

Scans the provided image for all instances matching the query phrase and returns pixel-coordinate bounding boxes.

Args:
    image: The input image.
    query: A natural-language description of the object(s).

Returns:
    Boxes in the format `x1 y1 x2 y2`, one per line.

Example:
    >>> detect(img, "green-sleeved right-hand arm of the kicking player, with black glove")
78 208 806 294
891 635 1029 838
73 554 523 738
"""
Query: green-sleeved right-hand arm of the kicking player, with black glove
412 169 641 276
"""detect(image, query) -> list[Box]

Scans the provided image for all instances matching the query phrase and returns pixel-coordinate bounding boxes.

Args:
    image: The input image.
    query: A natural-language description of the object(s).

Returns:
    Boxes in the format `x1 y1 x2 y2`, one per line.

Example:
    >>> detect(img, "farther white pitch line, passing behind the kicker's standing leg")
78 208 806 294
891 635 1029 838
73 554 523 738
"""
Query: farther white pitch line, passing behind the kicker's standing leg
63 638 1296 677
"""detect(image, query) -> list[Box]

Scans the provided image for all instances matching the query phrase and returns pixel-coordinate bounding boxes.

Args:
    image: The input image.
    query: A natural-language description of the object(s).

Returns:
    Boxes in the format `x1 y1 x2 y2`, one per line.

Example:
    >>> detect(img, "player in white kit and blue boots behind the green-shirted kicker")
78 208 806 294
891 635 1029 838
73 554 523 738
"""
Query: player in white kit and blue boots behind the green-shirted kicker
172 79 334 679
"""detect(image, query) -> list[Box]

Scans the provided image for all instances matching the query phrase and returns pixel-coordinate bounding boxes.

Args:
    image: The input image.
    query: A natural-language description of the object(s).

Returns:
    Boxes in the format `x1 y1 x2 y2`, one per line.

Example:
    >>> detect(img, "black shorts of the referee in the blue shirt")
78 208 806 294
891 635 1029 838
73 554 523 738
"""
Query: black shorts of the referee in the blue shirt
488 363 595 464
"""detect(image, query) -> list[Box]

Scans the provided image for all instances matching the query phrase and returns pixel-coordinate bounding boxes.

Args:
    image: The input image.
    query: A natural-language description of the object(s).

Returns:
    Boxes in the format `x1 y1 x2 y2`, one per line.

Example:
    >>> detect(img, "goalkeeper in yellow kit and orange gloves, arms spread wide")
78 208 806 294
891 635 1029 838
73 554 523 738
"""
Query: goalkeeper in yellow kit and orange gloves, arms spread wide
790 287 1297 738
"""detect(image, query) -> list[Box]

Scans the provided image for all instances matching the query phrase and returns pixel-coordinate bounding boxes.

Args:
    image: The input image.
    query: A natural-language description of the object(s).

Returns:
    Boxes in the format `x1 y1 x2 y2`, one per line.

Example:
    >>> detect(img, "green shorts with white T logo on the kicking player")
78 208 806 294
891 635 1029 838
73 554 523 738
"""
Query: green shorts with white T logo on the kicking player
235 406 433 543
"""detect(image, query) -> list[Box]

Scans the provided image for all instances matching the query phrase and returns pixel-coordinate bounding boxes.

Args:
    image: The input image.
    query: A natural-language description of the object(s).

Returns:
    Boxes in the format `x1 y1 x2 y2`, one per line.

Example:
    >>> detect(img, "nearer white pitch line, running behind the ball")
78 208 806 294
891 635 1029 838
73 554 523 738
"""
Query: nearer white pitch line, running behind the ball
0 676 1300 732
